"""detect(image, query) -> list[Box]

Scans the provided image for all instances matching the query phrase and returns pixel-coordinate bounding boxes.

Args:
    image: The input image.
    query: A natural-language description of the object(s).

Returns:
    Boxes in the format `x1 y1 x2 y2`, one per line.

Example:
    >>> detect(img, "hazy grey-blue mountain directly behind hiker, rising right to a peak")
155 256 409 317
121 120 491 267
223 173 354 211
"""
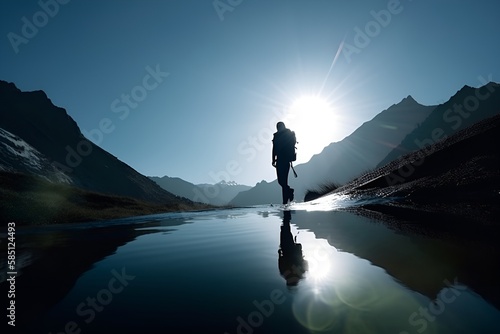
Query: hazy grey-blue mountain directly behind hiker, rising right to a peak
231 96 435 205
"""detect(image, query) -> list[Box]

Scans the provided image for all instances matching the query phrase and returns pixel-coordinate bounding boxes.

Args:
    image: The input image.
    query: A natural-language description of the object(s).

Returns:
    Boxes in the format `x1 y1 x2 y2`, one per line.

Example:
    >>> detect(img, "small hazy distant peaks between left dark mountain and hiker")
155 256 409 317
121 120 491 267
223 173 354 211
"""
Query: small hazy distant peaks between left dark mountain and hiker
149 176 252 206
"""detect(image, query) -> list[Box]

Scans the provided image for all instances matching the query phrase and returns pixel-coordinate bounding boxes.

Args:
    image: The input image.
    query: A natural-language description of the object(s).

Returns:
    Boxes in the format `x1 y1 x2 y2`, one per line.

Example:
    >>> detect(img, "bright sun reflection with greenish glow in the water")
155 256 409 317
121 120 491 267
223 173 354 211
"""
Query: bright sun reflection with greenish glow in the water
292 235 390 332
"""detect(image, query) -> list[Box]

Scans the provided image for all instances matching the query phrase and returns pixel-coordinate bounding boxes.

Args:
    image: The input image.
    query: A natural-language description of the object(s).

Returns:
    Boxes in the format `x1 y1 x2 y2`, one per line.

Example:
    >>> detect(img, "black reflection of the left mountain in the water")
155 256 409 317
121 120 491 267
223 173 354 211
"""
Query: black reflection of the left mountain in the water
0 220 188 333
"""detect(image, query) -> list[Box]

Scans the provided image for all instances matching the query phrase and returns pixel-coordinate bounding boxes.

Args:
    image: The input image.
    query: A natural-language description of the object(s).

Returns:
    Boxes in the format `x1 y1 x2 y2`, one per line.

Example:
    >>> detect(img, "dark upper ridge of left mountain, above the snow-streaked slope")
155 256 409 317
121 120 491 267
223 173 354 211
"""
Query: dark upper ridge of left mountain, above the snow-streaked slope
0 81 177 203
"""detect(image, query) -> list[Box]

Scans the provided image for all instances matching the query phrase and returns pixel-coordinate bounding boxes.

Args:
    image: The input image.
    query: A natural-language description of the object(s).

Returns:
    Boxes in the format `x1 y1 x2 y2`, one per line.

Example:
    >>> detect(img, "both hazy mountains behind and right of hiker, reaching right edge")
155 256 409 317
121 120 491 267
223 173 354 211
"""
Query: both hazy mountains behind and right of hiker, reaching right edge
230 83 500 206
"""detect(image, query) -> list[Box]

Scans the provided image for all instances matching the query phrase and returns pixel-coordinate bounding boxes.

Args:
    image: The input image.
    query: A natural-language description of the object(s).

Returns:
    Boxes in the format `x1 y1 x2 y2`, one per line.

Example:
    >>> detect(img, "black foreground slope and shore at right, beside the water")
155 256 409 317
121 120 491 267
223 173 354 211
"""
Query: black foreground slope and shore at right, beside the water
332 114 500 226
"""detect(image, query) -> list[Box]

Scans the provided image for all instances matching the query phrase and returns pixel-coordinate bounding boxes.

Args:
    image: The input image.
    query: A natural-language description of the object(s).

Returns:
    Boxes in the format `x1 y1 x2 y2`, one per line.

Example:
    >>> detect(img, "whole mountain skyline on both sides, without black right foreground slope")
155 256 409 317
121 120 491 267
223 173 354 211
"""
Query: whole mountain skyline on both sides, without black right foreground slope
0 81 500 222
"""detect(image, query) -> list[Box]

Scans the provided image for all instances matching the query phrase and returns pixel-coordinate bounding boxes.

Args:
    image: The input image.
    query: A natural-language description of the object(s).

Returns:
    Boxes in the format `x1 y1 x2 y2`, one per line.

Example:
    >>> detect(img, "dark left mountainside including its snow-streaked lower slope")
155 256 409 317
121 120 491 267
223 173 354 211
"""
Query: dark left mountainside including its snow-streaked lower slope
0 81 203 218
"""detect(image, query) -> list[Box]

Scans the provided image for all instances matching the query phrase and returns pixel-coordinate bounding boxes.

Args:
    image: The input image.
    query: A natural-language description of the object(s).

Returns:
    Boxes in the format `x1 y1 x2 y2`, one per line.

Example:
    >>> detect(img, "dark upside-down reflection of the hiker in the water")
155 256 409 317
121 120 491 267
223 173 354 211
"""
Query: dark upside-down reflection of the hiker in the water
278 211 307 286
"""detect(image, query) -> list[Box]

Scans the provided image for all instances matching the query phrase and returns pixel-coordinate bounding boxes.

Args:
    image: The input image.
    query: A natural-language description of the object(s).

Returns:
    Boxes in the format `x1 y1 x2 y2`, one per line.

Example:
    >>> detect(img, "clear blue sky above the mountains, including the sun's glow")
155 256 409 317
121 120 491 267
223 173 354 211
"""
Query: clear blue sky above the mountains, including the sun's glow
0 0 500 185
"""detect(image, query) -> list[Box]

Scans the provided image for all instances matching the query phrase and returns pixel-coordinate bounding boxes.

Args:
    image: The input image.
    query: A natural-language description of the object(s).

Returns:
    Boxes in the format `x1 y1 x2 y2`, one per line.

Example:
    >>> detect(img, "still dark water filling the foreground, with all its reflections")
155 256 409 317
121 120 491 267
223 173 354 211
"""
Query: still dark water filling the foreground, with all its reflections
1 200 500 334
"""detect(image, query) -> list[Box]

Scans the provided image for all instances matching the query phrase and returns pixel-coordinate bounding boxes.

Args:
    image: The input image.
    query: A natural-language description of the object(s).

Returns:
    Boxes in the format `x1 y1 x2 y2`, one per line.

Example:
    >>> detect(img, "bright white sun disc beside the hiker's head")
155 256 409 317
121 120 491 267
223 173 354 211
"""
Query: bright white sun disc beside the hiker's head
284 95 336 163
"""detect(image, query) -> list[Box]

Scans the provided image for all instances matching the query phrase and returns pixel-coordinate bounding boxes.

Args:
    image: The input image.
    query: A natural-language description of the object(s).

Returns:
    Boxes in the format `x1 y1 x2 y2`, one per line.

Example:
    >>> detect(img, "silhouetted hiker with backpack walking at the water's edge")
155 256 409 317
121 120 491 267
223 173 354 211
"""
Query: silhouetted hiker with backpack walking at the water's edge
272 122 297 204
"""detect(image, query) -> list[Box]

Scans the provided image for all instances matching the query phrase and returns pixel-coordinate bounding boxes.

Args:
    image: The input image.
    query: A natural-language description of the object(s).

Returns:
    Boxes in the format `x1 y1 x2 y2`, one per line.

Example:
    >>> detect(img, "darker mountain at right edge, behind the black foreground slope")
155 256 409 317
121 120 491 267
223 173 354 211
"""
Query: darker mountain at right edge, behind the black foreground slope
377 82 500 167
